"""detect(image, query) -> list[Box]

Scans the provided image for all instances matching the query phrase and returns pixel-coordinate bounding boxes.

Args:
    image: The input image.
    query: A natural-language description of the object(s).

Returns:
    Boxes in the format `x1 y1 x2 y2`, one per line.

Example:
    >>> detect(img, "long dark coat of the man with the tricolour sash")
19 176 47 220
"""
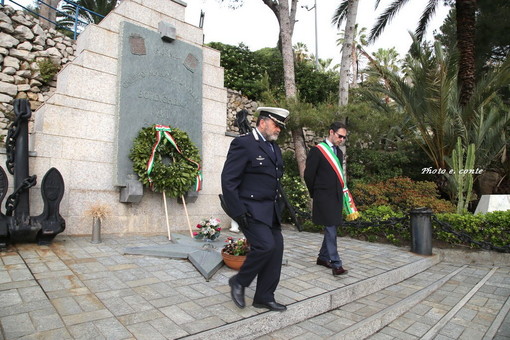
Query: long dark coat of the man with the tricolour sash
304 142 343 226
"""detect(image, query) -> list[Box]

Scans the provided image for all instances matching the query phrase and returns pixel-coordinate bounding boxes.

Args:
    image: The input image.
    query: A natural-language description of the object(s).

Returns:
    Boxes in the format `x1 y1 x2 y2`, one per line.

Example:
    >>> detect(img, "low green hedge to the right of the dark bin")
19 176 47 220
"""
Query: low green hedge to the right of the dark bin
433 210 510 248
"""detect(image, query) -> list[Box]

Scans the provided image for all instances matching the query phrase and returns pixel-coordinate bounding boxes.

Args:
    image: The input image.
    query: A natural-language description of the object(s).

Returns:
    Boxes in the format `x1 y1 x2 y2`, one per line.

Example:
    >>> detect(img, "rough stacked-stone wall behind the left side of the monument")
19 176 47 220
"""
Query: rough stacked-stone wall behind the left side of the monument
0 6 76 136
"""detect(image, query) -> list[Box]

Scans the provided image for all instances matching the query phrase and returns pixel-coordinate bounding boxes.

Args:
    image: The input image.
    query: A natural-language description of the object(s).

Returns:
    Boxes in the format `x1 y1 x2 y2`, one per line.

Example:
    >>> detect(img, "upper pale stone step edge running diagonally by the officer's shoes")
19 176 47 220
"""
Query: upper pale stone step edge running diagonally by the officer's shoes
182 256 440 340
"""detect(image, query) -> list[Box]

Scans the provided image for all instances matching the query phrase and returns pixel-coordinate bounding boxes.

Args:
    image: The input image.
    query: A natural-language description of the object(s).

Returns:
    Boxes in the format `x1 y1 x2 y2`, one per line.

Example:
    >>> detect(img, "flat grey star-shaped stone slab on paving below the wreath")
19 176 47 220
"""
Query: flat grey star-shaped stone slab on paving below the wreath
124 234 224 281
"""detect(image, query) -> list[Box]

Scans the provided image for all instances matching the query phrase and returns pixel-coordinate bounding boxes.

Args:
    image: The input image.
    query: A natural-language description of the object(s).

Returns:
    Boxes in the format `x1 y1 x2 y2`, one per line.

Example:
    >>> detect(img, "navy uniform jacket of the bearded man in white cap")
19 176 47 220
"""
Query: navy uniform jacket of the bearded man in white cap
221 130 283 226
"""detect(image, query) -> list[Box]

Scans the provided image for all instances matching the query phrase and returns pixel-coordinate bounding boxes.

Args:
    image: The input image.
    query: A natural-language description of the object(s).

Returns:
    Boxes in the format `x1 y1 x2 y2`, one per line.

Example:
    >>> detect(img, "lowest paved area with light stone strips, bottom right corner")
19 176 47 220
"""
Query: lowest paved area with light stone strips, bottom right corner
369 266 510 340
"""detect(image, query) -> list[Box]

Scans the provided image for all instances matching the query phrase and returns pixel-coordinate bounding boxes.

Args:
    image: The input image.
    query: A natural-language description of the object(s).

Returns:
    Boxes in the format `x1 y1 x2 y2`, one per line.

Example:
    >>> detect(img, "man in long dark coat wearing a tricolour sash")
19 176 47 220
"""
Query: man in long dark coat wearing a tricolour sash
304 122 347 275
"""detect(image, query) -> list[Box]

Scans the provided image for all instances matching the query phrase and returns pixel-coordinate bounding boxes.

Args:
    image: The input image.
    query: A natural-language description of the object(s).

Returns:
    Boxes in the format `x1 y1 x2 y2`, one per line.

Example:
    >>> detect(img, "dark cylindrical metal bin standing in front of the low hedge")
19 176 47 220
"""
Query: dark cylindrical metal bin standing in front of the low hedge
410 207 432 255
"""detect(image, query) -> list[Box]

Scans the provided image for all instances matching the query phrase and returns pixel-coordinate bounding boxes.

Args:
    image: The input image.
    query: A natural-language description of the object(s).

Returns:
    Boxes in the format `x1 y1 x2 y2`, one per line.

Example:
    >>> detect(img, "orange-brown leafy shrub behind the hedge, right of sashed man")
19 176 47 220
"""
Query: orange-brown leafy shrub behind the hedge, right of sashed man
352 177 455 213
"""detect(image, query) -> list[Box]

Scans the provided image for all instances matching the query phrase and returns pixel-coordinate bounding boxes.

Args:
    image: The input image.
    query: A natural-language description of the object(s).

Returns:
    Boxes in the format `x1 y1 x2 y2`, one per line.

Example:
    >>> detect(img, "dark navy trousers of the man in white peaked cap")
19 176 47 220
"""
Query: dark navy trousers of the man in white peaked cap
236 218 283 303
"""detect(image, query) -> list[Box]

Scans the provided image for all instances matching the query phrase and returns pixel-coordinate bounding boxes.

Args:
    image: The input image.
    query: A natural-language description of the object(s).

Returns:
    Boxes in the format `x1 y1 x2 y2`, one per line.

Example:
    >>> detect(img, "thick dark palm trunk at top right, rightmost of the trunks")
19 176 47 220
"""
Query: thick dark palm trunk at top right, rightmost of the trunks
455 0 476 106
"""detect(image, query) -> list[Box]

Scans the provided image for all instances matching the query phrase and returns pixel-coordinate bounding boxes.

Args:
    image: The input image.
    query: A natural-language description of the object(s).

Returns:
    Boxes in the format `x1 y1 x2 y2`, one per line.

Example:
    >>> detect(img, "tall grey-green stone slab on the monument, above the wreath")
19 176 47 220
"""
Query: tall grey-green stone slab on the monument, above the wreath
114 22 203 187
